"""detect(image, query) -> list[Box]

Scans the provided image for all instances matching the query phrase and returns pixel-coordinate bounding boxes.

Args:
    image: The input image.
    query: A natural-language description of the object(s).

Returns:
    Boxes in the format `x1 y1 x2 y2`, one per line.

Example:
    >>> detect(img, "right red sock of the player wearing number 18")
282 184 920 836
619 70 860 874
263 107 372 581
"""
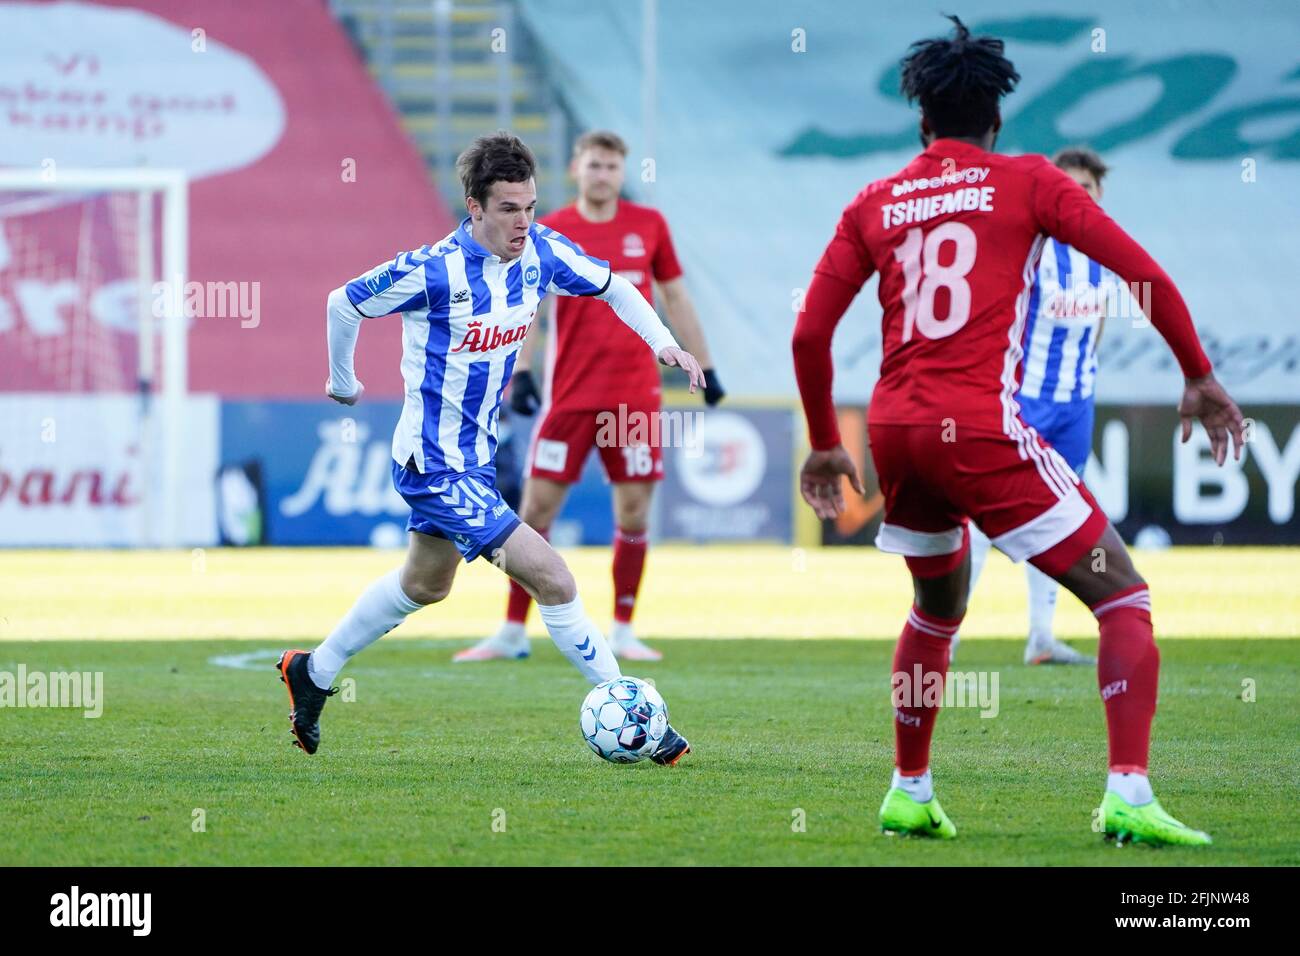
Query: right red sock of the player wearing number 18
1092 584 1160 774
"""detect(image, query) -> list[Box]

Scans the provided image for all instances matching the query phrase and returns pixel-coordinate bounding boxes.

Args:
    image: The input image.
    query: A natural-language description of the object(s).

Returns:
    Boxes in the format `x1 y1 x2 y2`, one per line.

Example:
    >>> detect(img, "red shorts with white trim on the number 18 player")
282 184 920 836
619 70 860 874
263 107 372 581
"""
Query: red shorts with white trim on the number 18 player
868 424 1106 578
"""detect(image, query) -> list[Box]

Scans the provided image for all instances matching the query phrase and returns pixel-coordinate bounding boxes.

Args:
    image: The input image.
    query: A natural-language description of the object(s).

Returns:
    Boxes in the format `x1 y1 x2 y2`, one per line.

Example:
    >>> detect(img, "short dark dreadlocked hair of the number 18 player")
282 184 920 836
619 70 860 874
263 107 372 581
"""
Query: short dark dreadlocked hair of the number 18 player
901 16 1021 137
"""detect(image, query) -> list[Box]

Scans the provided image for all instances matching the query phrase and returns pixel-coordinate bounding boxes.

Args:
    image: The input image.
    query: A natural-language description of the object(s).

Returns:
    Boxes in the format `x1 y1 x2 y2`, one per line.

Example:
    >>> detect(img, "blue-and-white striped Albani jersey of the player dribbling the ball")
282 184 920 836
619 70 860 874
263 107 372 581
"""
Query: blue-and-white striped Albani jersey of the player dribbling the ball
346 219 610 475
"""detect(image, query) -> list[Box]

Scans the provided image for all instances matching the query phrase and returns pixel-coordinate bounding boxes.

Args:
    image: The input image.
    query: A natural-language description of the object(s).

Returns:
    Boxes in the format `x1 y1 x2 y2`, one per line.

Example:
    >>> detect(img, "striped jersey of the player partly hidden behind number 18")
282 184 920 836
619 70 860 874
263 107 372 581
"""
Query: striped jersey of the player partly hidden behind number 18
1017 238 1119 402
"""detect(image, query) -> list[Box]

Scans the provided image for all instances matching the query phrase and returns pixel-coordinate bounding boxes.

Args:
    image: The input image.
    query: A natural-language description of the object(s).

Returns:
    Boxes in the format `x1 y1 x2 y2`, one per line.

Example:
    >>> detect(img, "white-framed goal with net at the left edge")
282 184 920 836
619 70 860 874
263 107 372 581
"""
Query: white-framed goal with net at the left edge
0 168 187 546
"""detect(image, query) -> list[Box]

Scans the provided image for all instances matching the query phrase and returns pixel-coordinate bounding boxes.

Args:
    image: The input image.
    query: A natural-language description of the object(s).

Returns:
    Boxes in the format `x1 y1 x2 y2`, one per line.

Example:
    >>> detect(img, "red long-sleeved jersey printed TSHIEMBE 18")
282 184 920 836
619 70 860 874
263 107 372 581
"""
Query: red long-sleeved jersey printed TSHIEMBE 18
816 139 1210 434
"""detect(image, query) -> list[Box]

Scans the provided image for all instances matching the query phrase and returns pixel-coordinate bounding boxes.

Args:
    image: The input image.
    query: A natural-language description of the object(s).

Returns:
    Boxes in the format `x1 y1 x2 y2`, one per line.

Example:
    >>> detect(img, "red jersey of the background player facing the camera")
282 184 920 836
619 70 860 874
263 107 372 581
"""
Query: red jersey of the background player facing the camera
541 200 681 411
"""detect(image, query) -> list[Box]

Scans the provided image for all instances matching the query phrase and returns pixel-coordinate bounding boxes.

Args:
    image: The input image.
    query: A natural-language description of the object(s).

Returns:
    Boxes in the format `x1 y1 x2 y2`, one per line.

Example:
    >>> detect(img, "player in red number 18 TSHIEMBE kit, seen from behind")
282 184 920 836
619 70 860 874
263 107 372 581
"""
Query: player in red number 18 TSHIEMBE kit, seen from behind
793 17 1243 844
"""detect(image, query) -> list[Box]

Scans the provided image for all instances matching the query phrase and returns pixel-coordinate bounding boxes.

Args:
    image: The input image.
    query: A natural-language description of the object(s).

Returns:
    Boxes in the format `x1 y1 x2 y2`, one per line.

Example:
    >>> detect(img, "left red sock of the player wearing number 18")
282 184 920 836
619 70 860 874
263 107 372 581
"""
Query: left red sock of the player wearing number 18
891 606 962 777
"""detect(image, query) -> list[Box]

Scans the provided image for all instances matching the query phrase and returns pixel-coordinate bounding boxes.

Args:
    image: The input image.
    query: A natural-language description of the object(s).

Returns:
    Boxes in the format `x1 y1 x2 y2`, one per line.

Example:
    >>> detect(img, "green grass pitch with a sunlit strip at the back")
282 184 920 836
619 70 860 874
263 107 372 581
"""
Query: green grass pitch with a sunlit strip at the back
0 546 1300 866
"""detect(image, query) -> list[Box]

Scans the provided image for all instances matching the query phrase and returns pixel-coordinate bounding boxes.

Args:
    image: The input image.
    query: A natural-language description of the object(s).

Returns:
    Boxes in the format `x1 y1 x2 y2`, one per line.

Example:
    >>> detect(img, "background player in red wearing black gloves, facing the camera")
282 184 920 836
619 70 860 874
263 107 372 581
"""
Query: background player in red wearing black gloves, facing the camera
452 130 725 662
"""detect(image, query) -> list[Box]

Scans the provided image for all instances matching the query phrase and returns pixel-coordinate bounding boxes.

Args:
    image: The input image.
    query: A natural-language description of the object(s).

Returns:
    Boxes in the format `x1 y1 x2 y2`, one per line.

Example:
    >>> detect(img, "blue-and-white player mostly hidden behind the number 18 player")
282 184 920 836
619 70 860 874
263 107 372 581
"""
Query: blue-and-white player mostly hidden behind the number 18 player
954 147 1121 663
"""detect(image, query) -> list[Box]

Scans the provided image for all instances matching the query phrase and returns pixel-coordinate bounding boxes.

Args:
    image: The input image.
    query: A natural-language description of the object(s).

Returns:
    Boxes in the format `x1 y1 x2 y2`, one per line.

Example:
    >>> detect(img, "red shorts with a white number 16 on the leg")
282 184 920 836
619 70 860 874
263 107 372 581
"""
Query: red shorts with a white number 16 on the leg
528 397 663 484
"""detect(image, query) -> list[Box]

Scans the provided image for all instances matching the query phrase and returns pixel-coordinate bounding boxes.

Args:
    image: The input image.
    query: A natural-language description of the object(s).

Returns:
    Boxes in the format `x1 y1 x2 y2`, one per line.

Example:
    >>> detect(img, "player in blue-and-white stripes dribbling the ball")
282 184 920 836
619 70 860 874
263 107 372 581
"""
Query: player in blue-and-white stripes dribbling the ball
277 133 705 765
